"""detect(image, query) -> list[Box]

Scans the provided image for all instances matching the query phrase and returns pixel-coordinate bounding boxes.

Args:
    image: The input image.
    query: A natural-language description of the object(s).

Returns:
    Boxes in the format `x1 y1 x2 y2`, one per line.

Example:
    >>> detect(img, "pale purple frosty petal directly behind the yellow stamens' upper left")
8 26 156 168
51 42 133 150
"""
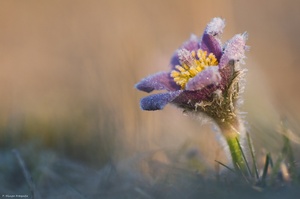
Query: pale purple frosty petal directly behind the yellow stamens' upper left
171 34 199 69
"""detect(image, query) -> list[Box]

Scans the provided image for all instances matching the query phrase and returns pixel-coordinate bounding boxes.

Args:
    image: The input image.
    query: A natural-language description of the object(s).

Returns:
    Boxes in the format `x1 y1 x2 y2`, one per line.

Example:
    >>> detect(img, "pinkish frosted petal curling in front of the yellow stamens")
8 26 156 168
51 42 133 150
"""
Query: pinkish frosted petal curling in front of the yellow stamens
185 66 221 91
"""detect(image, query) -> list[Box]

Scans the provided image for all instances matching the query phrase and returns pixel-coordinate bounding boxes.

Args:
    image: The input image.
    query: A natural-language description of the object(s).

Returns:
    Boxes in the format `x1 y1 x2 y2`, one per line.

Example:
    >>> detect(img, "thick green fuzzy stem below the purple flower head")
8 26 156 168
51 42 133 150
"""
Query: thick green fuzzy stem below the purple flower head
218 119 247 173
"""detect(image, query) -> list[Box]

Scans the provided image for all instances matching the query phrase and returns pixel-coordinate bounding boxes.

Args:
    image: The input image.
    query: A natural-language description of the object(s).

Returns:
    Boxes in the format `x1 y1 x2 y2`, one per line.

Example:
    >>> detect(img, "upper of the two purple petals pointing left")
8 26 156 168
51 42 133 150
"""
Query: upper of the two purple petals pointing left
135 72 180 93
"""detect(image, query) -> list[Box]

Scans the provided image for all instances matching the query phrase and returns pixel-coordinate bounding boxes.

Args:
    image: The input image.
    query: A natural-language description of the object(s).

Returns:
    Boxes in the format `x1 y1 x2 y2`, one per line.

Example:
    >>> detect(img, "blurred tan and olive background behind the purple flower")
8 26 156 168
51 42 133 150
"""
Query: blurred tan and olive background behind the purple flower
0 0 300 196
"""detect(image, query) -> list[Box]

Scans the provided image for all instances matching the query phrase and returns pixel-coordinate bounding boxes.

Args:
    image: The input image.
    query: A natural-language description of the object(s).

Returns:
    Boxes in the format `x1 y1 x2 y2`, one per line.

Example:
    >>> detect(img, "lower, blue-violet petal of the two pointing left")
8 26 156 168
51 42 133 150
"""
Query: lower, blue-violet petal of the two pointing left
140 90 183 111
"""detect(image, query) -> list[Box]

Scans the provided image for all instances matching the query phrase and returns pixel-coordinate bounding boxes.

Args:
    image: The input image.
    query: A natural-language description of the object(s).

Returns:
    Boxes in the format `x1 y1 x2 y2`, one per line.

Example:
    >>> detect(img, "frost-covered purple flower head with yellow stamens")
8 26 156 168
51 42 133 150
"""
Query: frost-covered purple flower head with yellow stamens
135 18 247 112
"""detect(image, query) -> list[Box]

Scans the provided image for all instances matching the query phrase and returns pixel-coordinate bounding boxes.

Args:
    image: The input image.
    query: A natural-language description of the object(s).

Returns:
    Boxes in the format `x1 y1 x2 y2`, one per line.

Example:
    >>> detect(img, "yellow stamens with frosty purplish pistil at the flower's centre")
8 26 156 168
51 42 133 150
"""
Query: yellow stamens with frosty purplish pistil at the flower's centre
171 49 218 89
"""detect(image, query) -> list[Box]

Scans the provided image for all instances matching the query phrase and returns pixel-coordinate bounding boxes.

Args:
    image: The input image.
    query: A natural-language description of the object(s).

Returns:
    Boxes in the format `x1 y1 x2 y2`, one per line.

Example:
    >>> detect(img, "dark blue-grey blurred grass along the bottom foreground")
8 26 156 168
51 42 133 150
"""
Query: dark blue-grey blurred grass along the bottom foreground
0 142 300 199
